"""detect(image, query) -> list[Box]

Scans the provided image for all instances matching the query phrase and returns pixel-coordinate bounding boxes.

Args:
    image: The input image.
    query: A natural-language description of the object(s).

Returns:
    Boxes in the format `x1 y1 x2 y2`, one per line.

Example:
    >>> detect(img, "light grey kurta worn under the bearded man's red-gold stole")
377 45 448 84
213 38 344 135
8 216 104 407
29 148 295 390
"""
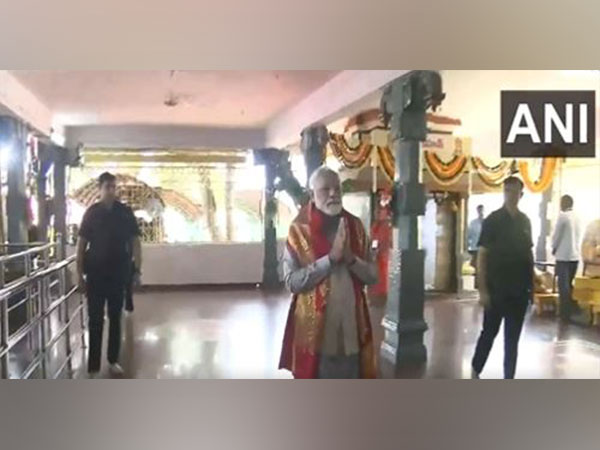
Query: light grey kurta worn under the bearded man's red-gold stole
283 227 377 356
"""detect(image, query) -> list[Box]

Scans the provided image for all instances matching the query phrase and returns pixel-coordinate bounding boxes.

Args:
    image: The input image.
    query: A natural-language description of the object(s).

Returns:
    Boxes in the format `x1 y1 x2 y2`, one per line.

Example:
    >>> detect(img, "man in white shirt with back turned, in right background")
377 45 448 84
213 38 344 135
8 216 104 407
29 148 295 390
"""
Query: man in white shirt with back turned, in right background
552 195 580 320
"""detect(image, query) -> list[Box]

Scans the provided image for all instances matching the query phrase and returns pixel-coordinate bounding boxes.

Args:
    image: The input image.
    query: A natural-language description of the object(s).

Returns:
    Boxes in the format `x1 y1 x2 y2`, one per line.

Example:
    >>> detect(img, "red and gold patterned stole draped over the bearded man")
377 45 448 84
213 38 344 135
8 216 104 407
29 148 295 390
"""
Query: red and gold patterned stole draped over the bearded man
279 203 377 378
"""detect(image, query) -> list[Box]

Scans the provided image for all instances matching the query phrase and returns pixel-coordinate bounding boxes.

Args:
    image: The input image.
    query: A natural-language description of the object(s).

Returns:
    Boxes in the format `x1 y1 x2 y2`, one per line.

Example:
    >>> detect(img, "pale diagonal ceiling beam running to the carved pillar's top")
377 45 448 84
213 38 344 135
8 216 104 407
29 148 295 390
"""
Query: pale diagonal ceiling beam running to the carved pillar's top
266 70 408 147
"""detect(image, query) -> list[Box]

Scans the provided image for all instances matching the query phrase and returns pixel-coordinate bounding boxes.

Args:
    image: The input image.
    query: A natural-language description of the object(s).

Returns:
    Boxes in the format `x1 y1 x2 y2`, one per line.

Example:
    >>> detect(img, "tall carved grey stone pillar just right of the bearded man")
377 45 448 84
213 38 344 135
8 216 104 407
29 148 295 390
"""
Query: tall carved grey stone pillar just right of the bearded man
380 71 444 377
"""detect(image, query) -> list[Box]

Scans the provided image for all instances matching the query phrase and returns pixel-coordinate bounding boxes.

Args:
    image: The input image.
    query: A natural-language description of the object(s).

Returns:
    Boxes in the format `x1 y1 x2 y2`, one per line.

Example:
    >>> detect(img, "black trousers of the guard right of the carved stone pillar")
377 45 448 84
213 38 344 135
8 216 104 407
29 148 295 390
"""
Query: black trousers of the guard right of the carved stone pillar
472 294 529 379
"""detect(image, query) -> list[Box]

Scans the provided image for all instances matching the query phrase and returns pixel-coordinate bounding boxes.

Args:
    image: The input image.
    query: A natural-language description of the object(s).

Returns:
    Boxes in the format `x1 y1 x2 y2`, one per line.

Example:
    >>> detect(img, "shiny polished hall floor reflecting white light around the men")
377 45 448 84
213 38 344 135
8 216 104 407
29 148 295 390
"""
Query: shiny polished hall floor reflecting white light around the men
55 289 600 379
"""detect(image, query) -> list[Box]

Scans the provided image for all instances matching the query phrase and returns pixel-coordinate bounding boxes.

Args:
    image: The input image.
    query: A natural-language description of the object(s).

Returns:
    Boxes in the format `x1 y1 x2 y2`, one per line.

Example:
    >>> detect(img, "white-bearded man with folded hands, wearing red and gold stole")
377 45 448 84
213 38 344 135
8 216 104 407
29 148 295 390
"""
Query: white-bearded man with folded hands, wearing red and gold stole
279 167 377 378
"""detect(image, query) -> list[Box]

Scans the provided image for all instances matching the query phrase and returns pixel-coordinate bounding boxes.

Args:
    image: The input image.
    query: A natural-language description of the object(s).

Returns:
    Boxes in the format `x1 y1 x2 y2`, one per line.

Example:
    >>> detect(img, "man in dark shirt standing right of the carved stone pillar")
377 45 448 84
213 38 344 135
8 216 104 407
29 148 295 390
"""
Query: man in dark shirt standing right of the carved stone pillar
472 177 533 378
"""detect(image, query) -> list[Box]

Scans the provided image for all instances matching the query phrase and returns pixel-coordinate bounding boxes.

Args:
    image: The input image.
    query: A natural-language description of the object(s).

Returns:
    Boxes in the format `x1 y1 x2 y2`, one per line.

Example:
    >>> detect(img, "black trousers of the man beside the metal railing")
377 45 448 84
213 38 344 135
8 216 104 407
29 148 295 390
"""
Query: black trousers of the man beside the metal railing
87 275 125 372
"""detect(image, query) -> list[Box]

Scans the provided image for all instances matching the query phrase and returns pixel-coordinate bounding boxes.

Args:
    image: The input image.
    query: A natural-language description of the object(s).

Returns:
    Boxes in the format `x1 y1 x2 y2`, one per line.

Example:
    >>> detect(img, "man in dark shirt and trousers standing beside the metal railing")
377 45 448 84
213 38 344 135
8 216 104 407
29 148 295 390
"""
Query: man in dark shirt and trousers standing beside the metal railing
77 172 141 378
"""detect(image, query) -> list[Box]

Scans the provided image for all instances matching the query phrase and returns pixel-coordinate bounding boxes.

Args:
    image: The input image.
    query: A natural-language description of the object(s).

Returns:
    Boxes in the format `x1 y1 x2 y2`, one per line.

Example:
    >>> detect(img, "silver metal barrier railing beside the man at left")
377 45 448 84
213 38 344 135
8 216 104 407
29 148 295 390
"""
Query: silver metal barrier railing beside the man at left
0 239 86 378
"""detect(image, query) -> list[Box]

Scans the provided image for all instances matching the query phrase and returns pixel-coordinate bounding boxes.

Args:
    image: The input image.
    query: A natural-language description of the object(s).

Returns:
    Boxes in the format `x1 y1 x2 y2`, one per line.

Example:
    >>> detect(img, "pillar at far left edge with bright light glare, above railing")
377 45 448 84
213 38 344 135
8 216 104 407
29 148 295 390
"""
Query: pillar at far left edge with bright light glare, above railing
0 116 27 248
